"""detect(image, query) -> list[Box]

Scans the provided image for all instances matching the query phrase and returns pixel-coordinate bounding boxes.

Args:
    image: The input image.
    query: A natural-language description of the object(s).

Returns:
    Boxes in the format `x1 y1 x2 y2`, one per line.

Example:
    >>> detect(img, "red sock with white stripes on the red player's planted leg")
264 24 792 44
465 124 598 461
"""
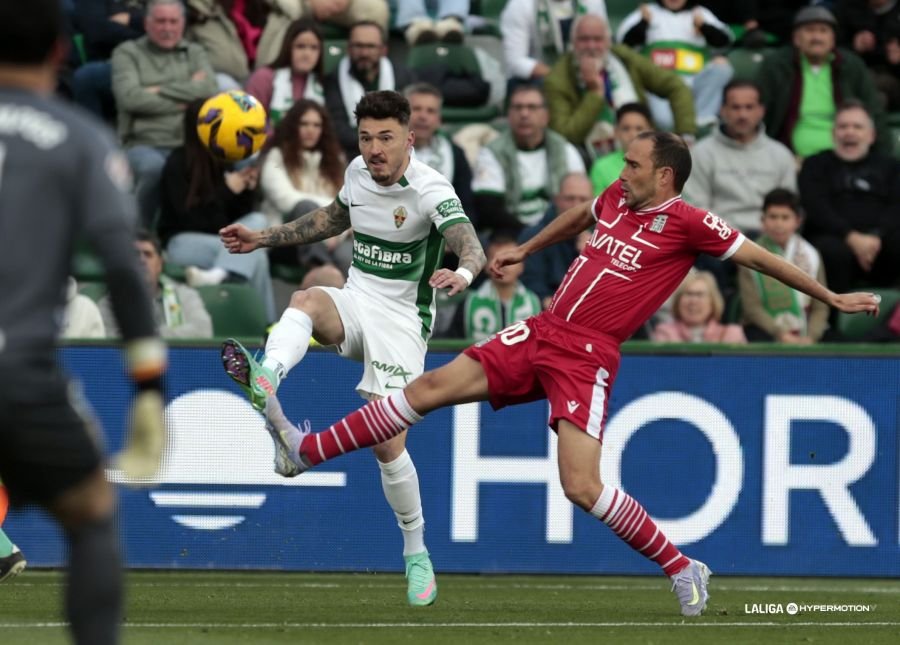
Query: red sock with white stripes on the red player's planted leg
591 486 691 576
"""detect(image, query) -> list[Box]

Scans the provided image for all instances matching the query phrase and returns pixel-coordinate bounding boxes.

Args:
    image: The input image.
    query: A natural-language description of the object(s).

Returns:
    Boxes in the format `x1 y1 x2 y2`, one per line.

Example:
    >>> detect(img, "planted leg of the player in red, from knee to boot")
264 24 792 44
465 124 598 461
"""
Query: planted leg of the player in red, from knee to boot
558 419 710 616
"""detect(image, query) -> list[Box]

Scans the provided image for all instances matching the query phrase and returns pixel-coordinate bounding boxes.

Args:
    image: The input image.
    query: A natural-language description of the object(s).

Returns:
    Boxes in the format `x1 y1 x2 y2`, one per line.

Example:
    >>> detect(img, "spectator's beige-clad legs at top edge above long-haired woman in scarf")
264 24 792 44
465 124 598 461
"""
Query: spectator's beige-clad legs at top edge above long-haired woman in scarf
256 0 393 68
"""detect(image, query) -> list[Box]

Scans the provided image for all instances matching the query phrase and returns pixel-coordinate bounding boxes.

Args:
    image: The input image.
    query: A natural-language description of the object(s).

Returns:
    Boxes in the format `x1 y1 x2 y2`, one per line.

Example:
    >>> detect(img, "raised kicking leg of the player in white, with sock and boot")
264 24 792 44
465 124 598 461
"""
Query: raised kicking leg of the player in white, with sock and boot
222 289 344 410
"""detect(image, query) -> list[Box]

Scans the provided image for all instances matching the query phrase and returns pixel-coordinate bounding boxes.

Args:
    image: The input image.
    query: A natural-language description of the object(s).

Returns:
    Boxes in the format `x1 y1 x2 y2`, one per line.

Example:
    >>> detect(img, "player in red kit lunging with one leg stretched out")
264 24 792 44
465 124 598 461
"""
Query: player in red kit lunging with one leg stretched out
258 132 878 616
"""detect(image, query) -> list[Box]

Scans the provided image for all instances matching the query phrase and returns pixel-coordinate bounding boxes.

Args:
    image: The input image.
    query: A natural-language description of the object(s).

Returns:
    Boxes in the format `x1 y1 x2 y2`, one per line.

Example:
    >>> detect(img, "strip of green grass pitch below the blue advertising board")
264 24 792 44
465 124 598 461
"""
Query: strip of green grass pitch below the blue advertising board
0 571 900 645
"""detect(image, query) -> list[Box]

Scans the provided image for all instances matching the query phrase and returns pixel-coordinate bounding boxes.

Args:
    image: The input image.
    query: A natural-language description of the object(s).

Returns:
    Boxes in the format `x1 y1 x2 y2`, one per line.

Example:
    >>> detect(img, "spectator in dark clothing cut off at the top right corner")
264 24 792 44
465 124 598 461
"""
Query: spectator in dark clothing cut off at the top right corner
835 0 900 112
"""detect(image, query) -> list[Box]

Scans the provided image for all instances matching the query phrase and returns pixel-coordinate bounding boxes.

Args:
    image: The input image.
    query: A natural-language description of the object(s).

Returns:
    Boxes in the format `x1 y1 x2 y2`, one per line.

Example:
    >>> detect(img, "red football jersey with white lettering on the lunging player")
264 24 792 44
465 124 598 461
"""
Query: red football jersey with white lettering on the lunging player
550 181 745 341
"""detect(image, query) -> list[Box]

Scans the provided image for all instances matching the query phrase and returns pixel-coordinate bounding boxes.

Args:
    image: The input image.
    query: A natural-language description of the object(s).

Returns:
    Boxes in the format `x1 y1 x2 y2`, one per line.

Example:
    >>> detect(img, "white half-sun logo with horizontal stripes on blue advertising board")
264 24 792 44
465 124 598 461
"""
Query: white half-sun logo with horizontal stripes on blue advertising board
107 389 347 531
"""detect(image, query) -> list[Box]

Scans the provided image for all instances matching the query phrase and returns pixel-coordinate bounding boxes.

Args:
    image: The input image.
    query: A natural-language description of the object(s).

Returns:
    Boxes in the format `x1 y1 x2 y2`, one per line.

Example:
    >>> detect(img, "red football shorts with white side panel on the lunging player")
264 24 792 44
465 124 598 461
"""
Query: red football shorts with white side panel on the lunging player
464 312 619 441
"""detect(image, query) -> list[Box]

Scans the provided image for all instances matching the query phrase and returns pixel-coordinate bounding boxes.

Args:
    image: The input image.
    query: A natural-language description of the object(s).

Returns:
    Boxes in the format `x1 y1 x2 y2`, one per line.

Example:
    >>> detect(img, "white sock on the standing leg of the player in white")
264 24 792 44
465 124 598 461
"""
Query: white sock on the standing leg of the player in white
376 450 425 555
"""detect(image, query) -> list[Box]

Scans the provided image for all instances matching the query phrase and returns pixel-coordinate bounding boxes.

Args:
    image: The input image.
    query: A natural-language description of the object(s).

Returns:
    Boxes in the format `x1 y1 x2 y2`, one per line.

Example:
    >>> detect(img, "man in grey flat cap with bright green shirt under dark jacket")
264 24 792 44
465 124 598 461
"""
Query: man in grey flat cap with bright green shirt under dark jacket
758 7 890 158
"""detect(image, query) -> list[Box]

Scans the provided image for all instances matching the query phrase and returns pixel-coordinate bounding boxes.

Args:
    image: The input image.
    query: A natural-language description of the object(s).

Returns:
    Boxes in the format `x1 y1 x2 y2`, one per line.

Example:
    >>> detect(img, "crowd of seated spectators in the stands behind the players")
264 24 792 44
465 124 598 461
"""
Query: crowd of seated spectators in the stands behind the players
59 0 900 344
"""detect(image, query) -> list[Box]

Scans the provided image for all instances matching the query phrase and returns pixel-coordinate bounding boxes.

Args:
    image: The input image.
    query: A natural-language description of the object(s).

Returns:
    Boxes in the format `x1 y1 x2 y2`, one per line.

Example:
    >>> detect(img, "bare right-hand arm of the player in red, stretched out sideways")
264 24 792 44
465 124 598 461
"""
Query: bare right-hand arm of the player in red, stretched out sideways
732 240 881 315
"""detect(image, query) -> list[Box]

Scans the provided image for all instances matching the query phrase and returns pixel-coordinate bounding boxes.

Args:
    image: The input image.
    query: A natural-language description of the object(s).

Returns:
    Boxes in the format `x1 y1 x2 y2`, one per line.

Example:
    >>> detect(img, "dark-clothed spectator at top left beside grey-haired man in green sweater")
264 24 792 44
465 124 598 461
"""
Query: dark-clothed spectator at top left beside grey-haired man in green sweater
72 0 146 122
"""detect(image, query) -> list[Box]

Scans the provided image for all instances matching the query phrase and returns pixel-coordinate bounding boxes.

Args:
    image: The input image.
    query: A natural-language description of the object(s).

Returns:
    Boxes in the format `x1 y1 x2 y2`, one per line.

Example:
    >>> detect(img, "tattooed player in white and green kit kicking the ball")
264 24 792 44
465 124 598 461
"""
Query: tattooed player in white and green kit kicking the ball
220 91 485 606
